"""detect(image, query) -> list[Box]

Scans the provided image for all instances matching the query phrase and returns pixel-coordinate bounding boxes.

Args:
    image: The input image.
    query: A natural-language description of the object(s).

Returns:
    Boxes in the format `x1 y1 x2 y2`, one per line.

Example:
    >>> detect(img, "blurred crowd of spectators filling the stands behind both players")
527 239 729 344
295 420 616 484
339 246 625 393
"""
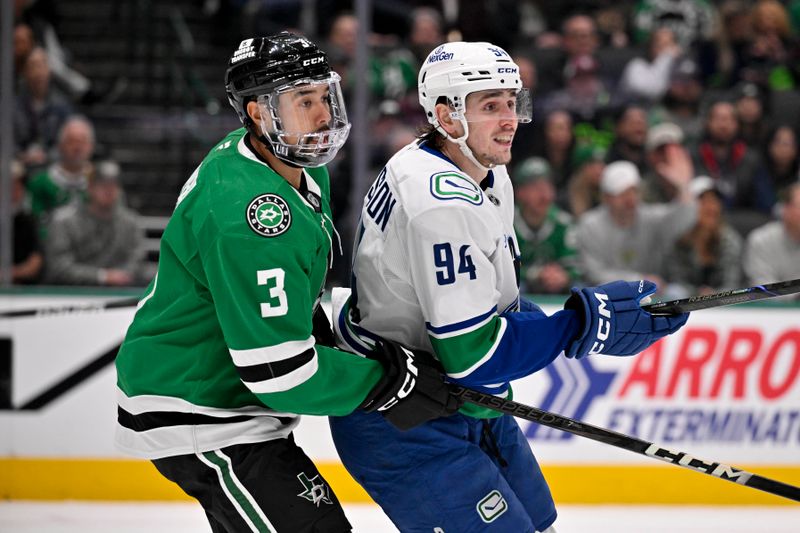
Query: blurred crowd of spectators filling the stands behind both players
6 0 800 297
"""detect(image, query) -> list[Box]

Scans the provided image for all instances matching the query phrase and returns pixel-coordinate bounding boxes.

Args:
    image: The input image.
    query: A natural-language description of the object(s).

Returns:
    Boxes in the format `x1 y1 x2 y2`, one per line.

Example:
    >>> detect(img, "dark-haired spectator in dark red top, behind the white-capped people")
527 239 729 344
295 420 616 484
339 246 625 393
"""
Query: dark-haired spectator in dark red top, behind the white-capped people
692 101 760 209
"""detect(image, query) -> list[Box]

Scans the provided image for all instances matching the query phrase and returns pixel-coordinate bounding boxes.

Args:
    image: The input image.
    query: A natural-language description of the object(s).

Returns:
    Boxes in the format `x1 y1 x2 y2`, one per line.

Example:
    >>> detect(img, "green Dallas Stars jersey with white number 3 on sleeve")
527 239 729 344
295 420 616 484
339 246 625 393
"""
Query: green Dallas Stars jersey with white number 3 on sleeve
116 129 382 458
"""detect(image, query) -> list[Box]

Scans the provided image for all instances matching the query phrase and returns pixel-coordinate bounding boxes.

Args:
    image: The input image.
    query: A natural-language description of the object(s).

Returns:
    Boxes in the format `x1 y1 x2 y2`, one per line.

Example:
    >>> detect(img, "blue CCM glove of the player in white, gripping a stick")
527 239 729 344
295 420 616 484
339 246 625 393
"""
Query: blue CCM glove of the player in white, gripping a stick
564 280 689 359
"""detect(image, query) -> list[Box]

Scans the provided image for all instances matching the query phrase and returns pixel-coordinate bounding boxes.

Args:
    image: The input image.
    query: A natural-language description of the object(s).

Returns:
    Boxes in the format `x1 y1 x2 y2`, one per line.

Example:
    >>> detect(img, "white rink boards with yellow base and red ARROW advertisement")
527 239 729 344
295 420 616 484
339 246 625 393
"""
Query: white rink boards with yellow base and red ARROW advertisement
0 293 800 505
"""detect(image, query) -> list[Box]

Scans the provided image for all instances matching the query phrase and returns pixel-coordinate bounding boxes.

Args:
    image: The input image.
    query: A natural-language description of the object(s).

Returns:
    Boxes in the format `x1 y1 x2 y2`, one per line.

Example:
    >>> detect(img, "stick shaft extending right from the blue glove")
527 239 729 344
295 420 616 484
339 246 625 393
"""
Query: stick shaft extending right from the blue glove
642 279 800 315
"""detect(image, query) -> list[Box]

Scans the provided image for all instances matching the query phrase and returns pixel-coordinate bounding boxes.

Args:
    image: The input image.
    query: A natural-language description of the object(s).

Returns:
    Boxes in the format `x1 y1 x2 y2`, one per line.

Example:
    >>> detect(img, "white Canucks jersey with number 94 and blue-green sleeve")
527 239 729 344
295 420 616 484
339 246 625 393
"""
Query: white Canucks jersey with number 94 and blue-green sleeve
335 142 577 416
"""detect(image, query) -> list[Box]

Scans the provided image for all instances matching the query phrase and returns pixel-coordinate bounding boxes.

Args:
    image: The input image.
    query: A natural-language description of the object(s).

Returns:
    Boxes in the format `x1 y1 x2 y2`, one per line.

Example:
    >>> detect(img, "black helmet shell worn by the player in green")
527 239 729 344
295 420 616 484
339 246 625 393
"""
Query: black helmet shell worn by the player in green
225 31 331 127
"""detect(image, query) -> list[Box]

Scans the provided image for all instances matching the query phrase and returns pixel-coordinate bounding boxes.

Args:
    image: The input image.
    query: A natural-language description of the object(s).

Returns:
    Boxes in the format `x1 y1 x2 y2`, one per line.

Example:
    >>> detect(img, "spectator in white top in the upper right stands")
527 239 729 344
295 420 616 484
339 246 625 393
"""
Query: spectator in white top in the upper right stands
617 27 681 102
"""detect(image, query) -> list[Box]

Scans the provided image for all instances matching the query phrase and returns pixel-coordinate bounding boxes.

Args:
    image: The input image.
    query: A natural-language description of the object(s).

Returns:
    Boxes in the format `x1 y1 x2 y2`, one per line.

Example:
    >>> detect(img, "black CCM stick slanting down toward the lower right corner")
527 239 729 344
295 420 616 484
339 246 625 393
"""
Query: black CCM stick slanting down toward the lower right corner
451 385 800 502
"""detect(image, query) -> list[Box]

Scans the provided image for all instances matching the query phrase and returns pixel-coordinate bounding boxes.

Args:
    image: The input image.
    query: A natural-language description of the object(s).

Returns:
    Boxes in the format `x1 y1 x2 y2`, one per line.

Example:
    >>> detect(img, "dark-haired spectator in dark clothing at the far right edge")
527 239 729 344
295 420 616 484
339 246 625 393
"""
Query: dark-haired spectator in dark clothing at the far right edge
755 124 800 213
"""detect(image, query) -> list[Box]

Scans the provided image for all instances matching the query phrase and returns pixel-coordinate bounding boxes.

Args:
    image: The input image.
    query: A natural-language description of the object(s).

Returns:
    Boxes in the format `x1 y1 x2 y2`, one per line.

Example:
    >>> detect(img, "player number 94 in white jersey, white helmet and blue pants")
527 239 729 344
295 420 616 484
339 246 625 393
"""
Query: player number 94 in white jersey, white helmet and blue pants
331 42 688 533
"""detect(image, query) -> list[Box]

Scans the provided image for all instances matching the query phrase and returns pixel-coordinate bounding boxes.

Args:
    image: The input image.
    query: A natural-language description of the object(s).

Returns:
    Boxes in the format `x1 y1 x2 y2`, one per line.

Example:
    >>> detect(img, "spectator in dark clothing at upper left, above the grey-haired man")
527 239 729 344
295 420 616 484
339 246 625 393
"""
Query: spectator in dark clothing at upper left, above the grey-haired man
14 47 72 166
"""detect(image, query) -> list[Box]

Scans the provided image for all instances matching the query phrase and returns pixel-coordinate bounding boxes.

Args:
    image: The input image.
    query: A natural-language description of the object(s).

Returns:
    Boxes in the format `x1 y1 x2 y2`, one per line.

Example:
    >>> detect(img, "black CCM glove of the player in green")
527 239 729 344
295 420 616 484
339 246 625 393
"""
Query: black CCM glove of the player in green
360 340 462 431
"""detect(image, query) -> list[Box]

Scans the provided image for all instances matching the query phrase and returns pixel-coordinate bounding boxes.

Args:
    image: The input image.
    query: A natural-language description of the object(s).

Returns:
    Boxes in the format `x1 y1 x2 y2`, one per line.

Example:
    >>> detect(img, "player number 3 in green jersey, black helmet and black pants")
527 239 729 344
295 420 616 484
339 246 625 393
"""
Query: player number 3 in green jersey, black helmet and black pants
116 32 458 533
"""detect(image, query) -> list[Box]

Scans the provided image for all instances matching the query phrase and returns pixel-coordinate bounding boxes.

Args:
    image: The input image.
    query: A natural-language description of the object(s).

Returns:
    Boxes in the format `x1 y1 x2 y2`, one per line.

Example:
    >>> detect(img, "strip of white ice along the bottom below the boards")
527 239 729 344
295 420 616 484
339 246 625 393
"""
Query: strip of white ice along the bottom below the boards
0 501 800 533
